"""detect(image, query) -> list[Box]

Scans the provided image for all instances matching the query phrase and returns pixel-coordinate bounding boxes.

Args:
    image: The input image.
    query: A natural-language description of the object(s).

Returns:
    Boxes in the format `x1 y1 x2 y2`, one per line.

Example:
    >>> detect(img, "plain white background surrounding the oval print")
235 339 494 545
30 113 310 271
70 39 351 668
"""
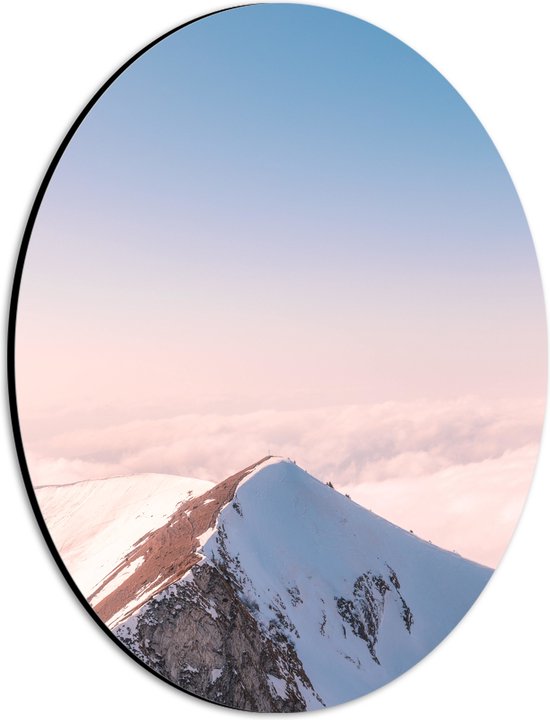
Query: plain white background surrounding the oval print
0 0 550 720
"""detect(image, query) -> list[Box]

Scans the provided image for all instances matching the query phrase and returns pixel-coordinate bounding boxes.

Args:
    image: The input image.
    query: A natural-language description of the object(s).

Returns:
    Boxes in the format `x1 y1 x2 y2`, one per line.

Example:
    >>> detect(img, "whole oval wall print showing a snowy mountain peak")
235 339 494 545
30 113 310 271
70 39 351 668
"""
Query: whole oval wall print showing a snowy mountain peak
10 4 546 712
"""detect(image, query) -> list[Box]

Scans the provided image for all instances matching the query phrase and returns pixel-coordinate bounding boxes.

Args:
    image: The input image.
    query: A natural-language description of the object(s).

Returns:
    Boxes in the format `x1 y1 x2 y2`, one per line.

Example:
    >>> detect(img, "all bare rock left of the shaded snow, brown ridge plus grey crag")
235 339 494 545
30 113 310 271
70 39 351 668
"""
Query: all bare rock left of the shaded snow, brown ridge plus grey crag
101 456 324 712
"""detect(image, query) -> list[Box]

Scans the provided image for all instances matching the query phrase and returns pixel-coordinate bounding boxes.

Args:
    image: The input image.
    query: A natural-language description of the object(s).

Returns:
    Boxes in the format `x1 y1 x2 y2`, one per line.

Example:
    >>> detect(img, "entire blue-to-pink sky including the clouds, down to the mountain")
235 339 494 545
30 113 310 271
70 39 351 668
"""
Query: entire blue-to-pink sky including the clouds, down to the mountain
12 4 546 564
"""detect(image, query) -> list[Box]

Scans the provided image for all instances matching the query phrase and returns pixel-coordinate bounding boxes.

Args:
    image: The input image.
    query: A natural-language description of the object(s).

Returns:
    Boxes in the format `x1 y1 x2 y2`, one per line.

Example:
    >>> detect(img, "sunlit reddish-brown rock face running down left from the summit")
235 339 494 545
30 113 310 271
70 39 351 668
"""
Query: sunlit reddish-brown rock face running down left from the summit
88 455 271 624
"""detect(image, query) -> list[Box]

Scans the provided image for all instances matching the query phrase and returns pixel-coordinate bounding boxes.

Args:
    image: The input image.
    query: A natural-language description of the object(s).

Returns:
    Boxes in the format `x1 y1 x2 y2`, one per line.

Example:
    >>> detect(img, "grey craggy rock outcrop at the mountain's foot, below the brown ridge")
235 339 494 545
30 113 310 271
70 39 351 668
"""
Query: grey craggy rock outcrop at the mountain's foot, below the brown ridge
115 563 313 712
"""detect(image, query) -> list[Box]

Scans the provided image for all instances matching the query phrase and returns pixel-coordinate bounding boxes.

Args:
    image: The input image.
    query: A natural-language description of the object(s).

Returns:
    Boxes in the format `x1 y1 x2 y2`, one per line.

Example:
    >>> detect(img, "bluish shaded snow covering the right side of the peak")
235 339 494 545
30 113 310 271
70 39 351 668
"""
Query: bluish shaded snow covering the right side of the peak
203 458 491 709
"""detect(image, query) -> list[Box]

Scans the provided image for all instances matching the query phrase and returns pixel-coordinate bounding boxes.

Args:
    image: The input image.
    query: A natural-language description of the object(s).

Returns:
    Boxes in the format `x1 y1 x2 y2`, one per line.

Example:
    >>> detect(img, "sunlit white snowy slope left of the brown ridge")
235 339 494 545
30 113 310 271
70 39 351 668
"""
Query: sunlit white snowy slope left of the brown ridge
35 474 212 597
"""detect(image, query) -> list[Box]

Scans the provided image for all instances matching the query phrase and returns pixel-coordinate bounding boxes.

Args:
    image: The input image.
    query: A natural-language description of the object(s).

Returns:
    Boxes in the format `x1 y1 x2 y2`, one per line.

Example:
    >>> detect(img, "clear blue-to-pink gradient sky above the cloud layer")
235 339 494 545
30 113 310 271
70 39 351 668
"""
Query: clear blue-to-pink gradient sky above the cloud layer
19 4 545 410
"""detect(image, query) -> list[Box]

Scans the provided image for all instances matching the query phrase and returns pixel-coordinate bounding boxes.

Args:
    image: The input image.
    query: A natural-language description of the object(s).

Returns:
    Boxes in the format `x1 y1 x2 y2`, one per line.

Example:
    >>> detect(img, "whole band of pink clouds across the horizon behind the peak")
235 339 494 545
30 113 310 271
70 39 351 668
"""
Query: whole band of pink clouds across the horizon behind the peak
23 397 544 564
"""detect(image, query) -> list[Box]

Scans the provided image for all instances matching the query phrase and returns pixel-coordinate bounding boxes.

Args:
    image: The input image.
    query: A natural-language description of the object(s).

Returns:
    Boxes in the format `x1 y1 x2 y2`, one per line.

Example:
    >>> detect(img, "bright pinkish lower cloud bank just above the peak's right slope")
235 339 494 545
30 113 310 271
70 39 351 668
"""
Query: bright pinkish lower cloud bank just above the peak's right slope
351 444 539 567
